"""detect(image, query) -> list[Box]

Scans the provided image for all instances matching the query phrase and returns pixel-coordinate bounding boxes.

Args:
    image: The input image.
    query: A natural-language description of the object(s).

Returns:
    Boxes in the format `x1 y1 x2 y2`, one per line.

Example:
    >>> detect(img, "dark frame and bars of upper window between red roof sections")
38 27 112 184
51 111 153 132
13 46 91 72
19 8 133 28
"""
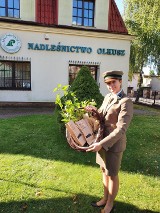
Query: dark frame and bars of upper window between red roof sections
72 0 95 27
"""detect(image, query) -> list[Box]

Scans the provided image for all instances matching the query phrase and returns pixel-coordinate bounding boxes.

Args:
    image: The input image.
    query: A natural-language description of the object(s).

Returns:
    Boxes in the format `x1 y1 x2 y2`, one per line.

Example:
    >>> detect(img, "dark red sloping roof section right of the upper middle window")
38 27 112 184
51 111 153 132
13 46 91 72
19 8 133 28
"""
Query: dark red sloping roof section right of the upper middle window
108 0 128 34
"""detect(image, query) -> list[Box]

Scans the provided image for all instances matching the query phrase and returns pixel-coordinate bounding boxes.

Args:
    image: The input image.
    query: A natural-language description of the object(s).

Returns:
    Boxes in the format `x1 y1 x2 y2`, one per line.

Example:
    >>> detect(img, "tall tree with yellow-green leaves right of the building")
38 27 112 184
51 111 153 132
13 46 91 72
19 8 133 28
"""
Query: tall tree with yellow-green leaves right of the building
124 0 160 101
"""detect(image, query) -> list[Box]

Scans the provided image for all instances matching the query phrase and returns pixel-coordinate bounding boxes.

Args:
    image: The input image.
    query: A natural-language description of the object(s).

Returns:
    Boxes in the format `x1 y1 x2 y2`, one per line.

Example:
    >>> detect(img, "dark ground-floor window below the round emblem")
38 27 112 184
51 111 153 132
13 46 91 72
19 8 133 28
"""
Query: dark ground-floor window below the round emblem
0 61 31 90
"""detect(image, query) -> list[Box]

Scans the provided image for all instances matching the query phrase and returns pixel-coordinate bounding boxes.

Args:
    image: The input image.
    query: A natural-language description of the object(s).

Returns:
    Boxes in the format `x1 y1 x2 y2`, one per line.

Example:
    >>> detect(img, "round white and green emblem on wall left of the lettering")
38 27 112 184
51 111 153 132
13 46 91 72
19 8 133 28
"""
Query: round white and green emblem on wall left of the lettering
0 33 21 53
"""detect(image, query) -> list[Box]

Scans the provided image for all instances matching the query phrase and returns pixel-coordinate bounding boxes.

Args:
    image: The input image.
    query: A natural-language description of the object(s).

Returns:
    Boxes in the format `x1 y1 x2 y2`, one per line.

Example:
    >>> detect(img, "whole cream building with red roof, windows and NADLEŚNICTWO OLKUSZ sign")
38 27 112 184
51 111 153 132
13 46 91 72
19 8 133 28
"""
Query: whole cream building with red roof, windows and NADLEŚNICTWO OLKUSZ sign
0 0 133 103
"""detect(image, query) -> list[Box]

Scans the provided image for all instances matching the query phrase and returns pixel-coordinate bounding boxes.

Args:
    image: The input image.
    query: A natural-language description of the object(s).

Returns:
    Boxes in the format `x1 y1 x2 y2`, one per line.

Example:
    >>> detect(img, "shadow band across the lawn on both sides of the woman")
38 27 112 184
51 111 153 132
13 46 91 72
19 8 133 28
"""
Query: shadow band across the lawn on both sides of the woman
0 115 159 176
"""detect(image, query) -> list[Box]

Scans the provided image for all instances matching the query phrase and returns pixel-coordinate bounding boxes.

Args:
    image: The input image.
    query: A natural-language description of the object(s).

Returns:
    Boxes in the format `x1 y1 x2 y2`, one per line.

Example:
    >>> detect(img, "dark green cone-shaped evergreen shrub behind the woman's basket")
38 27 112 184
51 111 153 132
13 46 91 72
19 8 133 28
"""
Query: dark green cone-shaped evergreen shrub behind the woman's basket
70 66 104 107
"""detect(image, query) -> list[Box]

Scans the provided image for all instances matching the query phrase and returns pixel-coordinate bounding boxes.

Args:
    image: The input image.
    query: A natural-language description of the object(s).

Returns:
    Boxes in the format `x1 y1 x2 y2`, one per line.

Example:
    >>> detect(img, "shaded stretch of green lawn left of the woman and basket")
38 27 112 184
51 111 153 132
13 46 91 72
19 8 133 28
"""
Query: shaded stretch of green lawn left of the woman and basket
0 115 96 166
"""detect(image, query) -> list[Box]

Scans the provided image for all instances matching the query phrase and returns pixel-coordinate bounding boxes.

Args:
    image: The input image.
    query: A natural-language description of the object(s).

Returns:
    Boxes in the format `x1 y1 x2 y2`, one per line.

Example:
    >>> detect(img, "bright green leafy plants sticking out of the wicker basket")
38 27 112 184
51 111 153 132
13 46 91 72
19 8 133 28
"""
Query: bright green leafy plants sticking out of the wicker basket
53 84 96 123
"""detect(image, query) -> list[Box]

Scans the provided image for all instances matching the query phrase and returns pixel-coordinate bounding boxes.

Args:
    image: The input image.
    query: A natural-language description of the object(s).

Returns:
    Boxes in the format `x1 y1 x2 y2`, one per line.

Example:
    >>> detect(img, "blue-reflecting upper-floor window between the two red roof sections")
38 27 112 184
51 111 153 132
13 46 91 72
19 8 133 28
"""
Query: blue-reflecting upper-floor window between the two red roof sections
72 0 95 27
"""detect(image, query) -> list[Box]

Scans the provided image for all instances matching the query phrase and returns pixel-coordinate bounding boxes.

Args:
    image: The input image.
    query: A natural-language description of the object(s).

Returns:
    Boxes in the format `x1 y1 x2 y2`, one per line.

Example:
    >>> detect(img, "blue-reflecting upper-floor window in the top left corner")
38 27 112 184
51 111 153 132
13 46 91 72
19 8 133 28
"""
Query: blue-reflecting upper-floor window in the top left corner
0 0 20 18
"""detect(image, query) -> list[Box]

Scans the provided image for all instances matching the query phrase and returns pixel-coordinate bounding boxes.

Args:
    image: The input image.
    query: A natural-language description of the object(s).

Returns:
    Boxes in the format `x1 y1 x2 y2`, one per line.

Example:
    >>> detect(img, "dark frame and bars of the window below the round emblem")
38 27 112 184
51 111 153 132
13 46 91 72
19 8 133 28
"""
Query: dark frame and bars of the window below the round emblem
0 60 31 91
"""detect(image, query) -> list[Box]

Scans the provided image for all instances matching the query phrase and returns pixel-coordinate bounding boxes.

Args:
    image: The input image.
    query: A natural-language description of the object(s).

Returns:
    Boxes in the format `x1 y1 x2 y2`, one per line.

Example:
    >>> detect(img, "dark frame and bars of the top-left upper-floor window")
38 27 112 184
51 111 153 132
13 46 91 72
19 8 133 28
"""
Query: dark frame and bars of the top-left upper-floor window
0 0 20 19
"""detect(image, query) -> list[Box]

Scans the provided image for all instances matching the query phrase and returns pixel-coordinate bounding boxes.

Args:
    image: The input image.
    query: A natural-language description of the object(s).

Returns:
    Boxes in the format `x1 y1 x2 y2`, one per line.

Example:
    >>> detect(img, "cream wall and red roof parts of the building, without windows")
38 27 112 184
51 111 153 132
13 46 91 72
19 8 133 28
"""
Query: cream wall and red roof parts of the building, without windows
0 0 133 102
